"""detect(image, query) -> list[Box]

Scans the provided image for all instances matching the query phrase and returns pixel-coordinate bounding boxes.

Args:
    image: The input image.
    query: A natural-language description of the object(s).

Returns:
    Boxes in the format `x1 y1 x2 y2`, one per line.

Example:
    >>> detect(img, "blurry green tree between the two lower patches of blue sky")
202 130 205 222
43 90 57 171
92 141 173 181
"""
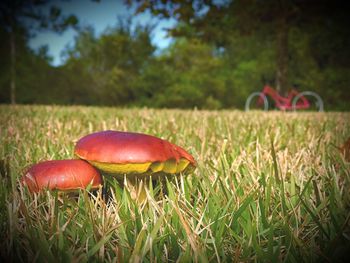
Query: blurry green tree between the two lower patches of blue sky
66 18 155 105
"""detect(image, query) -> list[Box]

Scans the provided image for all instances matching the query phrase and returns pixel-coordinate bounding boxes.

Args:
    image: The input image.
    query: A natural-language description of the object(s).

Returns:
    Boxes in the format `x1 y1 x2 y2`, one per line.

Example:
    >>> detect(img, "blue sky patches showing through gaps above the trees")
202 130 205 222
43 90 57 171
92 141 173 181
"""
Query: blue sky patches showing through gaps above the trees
29 0 175 66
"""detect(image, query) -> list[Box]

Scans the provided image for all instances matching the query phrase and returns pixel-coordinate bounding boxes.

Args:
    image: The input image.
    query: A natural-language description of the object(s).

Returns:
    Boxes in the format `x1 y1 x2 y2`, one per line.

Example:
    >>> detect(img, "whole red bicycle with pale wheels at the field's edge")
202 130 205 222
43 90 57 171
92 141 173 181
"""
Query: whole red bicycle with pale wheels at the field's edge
245 85 323 111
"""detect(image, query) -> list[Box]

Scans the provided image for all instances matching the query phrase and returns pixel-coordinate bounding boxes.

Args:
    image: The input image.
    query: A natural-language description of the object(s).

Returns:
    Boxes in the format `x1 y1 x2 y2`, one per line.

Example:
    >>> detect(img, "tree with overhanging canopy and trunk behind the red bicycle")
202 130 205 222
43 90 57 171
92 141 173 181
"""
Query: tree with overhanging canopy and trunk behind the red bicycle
128 0 349 93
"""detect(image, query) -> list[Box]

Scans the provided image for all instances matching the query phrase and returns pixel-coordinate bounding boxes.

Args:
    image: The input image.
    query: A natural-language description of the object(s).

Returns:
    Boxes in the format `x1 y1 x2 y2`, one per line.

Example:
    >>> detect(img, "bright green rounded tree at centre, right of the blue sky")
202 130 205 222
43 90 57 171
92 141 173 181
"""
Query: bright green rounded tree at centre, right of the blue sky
137 39 226 109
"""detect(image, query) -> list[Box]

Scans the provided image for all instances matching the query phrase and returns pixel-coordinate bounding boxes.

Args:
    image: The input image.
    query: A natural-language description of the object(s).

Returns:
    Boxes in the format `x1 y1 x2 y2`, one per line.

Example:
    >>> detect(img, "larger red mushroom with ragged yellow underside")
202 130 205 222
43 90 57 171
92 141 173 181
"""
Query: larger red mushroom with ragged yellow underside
74 130 196 201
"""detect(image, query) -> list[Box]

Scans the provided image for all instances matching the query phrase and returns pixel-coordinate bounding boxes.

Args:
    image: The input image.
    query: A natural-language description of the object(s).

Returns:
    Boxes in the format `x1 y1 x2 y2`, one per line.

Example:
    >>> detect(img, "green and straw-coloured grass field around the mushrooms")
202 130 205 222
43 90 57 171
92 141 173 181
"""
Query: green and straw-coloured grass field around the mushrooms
0 106 350 262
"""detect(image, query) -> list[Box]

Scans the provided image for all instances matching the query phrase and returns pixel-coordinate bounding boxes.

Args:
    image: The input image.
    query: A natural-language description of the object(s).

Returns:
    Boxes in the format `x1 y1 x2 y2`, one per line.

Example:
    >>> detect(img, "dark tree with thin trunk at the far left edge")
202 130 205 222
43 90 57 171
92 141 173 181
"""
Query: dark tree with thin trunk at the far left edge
0 0 78 104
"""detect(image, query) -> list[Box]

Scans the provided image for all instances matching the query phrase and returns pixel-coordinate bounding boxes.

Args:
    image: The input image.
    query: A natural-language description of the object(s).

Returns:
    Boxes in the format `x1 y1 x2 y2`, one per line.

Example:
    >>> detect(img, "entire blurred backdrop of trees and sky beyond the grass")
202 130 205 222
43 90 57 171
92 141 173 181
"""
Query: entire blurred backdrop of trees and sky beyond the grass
0 0 350 110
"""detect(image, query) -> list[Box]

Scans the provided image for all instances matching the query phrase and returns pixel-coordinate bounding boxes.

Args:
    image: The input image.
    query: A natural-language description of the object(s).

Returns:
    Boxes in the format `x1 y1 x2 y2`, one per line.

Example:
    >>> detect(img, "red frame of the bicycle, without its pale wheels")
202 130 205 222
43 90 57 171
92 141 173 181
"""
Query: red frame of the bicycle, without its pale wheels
258 85 310 110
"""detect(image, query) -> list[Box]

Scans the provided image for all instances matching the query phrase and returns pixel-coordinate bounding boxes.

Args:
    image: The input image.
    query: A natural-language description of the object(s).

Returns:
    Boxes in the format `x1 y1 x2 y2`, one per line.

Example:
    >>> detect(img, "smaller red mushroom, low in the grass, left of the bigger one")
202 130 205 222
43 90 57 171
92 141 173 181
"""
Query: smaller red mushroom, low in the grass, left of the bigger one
22 160 102 192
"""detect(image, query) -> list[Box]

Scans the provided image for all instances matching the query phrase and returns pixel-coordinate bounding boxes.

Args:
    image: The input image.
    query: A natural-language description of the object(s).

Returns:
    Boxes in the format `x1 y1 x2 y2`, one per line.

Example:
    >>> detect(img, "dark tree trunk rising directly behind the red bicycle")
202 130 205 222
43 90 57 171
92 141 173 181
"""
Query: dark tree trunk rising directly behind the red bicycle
276 16 288 94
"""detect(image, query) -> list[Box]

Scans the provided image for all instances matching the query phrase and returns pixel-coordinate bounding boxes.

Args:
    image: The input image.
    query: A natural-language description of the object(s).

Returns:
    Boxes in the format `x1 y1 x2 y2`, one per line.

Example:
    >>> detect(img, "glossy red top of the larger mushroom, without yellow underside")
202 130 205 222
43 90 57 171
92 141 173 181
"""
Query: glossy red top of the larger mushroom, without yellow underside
75 131 195 166
